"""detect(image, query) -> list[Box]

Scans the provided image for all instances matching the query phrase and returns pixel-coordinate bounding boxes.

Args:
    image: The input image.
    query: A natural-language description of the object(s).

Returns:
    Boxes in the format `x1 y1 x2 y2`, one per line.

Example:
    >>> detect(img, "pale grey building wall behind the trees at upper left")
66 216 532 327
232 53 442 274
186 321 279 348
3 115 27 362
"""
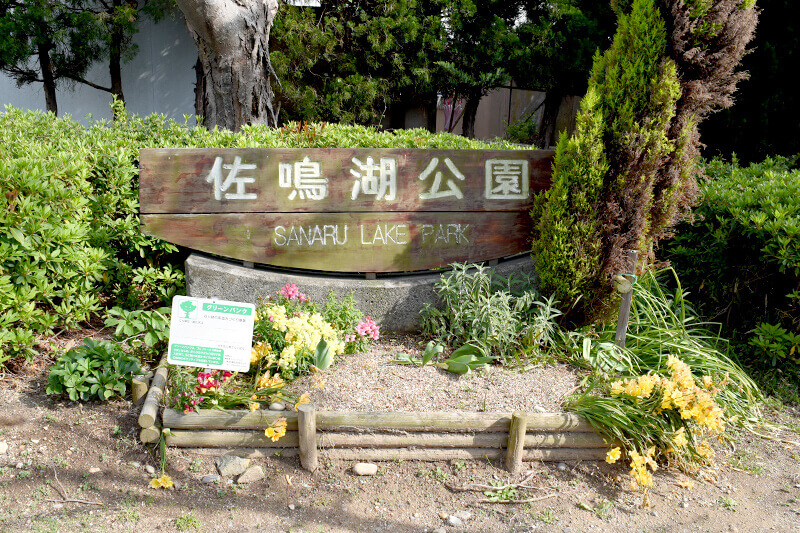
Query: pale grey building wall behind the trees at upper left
0 12 197 124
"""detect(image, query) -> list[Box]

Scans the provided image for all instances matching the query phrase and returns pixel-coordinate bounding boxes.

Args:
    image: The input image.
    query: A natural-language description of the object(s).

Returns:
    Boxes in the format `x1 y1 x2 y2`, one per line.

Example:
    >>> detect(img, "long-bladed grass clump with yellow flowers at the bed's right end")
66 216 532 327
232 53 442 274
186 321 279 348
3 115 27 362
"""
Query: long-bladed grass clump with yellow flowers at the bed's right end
567 269 763 498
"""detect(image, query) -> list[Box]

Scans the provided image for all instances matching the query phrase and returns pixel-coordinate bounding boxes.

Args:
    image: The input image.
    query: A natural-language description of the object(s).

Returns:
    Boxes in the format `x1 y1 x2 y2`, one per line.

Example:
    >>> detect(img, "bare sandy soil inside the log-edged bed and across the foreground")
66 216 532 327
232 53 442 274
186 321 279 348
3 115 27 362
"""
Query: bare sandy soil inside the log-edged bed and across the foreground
0 338 800 533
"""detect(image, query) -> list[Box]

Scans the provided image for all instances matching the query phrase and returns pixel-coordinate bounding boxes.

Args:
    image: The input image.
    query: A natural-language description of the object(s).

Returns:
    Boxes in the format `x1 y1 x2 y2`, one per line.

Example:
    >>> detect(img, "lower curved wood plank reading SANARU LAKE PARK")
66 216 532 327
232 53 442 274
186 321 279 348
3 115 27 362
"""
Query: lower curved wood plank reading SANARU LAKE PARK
141 212 532 272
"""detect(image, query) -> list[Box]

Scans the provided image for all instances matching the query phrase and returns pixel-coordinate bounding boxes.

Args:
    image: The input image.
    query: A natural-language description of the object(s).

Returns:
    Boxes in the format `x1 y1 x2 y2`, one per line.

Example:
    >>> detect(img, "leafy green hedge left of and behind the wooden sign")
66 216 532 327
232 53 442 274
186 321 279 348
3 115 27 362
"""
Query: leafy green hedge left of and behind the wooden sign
0 104 517 365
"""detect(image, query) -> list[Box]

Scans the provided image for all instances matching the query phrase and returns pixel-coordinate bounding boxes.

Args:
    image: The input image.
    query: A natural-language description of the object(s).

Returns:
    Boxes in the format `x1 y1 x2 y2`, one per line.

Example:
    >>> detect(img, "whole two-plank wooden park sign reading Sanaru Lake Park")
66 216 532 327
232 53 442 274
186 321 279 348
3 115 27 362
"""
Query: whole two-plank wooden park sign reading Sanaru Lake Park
139 148 553 272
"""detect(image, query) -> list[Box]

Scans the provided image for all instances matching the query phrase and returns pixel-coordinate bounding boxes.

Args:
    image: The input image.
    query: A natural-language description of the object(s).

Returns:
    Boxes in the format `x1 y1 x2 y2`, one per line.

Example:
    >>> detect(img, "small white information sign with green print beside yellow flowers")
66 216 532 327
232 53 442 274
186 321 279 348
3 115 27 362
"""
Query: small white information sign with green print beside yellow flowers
167 296 256 372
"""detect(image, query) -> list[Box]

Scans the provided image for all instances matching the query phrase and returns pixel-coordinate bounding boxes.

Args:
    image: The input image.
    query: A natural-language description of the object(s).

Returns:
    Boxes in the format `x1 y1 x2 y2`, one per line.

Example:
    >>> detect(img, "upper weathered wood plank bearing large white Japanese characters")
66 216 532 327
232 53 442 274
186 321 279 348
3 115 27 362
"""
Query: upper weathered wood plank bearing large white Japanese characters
139 148 554 214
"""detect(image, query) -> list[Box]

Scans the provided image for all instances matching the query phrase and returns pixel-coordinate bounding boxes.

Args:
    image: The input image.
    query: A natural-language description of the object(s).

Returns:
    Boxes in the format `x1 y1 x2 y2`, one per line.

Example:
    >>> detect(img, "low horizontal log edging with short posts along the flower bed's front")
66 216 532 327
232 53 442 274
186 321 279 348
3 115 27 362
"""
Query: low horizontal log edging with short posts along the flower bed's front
140 402 608 472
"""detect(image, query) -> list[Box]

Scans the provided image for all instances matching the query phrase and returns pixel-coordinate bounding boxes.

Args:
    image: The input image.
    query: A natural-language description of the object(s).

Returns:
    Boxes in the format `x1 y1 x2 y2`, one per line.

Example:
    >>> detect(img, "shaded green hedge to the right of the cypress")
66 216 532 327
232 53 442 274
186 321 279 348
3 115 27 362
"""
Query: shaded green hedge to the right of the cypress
662 154 800 373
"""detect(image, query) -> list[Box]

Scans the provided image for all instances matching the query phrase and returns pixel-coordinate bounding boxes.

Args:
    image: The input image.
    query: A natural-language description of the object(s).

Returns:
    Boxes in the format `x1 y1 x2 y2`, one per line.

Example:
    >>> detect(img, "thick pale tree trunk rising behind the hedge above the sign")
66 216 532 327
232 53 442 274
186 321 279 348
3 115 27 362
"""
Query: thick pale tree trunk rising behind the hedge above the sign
177 0 278 131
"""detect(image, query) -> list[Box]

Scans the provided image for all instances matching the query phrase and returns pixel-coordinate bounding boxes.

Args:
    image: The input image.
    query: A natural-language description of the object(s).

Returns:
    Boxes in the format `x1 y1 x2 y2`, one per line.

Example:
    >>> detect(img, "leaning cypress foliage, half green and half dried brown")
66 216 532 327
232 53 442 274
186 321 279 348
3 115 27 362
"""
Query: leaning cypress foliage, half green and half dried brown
533 0 757 322
